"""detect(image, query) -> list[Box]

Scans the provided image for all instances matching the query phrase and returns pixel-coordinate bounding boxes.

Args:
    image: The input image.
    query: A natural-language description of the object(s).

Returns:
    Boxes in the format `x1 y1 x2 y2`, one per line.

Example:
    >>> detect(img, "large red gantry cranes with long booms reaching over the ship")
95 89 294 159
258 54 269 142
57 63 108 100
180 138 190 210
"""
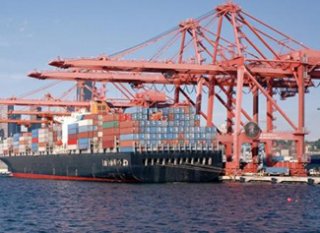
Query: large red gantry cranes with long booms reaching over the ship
29 2 320 175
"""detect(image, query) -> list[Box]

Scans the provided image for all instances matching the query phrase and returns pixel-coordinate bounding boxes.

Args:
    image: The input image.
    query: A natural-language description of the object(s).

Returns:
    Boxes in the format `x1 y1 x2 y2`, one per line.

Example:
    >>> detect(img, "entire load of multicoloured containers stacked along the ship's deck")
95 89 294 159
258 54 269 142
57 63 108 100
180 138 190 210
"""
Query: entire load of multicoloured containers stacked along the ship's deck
0 106 217 155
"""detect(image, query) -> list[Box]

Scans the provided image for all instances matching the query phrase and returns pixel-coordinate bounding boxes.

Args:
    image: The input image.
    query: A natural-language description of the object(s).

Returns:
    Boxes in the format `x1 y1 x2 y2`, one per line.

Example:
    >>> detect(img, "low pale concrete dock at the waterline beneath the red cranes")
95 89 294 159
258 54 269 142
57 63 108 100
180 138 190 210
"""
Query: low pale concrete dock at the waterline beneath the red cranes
221 175 320 185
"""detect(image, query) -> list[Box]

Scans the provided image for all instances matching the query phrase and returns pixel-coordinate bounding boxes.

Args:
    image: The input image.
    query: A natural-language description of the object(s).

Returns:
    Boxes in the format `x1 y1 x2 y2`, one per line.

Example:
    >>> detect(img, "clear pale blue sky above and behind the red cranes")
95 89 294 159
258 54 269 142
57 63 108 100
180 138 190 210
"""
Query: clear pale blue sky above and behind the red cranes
0 0 320 139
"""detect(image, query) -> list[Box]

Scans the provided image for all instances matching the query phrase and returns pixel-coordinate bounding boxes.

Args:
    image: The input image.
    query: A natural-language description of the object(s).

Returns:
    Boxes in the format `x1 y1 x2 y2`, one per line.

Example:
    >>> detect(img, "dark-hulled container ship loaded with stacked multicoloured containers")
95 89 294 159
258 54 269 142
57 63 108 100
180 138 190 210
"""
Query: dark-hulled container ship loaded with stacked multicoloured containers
0 105 223 183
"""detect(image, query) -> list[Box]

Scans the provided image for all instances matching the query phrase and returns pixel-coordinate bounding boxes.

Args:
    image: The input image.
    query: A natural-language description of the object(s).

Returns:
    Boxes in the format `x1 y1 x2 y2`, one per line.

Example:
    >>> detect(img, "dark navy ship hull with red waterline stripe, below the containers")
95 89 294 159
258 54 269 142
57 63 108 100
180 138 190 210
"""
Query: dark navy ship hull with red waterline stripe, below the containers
0 151 223 183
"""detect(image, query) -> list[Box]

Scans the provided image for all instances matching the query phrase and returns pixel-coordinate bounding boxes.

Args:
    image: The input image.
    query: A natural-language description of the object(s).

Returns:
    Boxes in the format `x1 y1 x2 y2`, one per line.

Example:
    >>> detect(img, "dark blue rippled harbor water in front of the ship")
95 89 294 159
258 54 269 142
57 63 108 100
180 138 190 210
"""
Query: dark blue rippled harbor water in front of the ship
0 178 320 233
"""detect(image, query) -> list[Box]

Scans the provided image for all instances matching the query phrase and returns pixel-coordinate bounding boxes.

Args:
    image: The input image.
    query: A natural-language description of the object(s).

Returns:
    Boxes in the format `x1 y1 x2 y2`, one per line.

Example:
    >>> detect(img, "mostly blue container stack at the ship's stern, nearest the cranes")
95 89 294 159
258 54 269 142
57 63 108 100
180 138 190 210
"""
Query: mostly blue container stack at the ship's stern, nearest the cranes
119 106 216 152
